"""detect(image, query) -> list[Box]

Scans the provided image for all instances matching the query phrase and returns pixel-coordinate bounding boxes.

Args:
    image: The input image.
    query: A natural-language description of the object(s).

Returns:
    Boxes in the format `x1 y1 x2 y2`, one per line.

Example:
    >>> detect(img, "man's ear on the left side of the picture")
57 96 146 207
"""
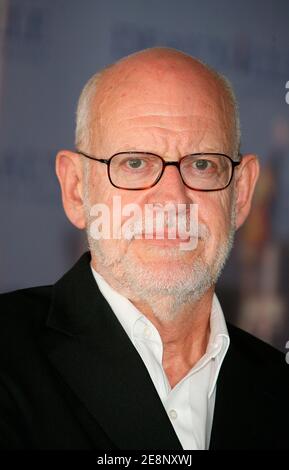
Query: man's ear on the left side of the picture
55 150 86 229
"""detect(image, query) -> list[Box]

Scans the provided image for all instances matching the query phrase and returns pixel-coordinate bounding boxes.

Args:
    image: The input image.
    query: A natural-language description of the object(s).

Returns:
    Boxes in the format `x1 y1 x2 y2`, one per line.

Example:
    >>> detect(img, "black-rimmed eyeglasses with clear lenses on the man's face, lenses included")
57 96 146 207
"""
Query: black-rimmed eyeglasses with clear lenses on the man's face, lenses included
76 150 242 191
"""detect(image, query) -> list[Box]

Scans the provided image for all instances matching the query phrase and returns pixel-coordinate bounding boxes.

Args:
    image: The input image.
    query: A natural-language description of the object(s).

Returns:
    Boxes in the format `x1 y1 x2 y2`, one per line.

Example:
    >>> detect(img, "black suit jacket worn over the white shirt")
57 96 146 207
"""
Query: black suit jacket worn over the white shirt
0 253 289 450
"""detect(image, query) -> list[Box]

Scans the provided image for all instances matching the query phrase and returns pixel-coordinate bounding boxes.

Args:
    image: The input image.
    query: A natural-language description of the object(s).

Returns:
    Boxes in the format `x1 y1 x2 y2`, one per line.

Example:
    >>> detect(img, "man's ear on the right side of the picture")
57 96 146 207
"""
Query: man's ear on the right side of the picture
235 154 260 229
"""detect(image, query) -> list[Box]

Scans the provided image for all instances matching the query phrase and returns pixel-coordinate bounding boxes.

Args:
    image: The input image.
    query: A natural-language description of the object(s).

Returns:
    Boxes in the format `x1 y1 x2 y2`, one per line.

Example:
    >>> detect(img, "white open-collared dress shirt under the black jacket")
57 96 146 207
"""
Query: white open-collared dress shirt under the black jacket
91 267 230 450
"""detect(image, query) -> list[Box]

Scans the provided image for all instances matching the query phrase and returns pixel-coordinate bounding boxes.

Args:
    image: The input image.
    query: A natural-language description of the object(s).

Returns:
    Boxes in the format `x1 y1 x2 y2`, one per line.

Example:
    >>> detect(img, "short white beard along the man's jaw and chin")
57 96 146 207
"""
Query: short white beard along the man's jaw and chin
88 225 235 321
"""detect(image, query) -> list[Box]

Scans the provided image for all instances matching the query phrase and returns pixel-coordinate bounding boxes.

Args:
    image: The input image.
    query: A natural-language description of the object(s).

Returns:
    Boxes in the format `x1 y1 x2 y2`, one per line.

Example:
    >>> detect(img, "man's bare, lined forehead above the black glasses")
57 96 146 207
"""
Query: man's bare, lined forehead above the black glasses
91 56 232 150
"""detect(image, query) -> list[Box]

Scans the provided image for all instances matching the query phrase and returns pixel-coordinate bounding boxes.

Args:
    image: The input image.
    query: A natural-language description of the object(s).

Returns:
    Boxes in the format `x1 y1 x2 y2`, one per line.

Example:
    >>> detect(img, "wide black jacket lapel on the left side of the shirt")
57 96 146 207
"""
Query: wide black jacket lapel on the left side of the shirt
42 253 182 450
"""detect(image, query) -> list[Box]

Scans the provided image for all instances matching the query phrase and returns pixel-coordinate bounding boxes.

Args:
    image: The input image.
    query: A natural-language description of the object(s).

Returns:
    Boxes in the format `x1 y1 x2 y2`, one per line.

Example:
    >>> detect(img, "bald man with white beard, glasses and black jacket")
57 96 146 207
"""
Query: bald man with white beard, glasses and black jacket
0 48 289 450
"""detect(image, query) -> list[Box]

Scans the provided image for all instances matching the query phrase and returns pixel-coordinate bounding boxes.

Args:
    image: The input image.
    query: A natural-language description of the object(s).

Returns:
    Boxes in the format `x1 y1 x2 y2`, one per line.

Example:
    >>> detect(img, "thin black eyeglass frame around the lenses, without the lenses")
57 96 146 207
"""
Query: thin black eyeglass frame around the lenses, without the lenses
75 150 243 192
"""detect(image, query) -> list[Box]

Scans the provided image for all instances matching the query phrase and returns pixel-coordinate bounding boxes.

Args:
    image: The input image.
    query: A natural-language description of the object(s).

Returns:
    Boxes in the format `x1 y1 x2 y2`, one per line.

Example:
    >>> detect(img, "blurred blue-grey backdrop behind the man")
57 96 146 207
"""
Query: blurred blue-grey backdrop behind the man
0 0 289 351
